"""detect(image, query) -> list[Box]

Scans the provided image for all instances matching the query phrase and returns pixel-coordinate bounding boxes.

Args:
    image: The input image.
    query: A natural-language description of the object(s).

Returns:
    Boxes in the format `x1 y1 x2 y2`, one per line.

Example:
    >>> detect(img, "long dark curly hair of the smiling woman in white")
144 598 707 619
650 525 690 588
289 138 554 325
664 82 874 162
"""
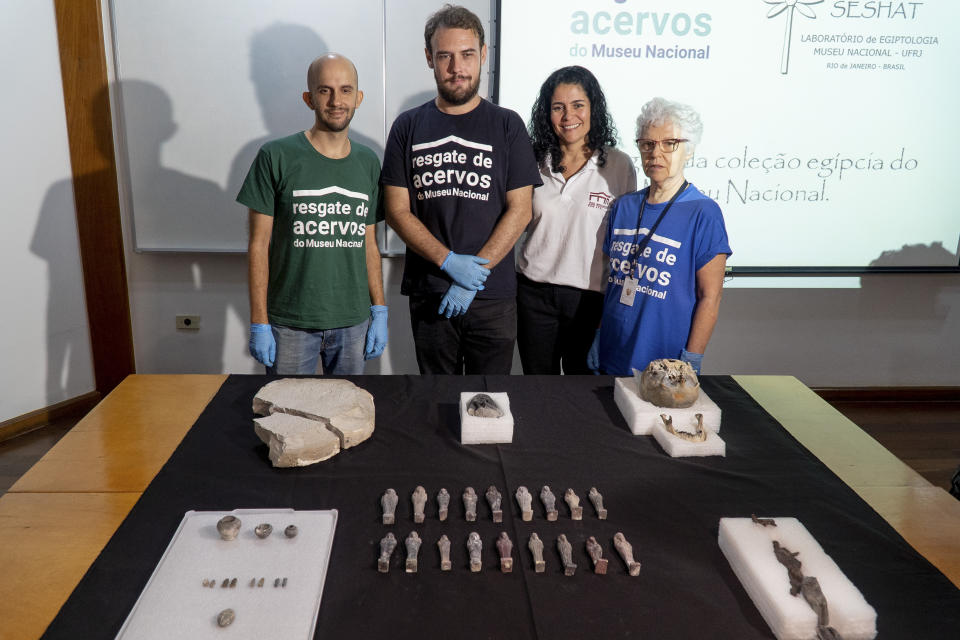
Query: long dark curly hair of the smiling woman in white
528 66 617 173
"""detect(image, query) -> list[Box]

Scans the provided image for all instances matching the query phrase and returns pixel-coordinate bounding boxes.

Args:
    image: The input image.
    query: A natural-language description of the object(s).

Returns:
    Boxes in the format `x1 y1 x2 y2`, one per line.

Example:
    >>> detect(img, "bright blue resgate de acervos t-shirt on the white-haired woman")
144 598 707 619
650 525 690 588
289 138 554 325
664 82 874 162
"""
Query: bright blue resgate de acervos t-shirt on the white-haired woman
600 184 731 375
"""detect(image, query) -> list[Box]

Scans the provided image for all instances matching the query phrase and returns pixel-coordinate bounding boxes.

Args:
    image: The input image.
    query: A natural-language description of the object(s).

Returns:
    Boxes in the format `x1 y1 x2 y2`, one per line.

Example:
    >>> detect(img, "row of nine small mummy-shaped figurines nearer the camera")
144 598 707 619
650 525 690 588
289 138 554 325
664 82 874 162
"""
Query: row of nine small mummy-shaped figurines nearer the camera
377 531 640 576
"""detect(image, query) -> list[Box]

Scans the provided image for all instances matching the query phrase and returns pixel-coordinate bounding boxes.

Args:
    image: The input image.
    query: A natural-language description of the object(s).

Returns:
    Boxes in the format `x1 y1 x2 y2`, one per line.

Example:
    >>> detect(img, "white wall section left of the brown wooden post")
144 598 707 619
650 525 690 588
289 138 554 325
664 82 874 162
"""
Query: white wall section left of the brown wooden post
0 0 94 422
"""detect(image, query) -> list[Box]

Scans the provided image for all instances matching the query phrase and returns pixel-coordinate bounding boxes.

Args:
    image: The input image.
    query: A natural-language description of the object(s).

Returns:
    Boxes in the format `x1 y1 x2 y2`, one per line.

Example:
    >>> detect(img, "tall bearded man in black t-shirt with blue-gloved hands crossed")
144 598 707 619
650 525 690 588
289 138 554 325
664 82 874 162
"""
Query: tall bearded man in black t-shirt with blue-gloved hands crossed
381 5 541 374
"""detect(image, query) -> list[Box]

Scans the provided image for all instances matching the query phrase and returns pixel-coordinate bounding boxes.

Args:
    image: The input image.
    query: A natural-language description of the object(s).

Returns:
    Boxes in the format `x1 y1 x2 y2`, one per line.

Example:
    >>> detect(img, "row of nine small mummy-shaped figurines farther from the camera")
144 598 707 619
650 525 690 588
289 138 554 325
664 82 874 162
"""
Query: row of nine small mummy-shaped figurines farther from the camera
380 485 607 524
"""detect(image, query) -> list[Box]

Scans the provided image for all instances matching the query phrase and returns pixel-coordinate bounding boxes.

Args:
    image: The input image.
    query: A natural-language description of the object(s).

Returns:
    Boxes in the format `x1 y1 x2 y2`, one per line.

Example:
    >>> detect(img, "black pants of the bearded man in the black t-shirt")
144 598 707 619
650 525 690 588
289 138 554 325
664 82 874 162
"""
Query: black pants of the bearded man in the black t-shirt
410 295 517 375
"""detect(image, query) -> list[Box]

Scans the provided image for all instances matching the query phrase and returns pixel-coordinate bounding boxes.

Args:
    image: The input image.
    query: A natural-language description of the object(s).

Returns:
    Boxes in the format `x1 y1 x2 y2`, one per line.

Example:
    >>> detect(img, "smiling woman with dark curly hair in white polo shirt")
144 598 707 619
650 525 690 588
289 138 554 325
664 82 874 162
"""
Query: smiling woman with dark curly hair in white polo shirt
517 66 637 374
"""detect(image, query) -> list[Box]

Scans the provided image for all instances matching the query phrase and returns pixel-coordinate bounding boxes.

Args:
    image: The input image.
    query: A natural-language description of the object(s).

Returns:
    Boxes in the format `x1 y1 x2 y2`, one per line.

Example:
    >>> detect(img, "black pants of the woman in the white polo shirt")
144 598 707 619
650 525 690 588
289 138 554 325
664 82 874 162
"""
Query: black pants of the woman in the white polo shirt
517 275 603 375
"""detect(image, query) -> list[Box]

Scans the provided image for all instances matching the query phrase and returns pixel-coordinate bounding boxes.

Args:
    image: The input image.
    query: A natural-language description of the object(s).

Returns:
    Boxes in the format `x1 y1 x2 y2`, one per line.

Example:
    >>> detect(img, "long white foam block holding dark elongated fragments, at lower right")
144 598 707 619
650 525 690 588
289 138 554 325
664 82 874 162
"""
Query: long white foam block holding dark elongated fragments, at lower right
718 518 877 640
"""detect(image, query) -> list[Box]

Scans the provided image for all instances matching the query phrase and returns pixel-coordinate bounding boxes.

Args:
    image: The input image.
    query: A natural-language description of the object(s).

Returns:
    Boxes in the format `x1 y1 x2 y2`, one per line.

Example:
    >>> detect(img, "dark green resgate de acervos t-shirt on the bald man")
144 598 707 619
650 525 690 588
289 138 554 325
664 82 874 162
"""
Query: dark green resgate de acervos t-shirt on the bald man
237 132 383 329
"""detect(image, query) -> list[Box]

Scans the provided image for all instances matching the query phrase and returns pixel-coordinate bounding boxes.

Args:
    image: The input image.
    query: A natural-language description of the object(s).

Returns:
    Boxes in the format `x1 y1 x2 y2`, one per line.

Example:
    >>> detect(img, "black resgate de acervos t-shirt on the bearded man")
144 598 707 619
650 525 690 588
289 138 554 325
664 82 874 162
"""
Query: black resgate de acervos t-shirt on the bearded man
380 100 541 299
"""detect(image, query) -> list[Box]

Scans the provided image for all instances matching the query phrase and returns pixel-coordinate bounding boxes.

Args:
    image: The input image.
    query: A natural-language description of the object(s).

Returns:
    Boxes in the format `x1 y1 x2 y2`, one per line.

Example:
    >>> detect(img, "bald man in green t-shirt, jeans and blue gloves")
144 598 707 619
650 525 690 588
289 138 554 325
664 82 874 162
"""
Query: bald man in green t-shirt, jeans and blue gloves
237 53 387 375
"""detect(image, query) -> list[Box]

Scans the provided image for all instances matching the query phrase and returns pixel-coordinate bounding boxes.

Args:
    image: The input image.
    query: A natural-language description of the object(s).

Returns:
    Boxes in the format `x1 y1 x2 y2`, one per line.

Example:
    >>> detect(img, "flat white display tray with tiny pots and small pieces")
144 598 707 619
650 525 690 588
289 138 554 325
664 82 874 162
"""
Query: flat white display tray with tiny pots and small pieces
117 509 337 640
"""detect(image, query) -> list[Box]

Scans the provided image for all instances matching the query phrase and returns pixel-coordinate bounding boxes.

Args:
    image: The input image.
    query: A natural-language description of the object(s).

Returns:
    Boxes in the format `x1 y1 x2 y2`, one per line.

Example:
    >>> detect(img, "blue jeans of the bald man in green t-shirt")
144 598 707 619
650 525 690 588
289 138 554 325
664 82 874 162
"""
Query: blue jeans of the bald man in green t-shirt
267 318 370 376
